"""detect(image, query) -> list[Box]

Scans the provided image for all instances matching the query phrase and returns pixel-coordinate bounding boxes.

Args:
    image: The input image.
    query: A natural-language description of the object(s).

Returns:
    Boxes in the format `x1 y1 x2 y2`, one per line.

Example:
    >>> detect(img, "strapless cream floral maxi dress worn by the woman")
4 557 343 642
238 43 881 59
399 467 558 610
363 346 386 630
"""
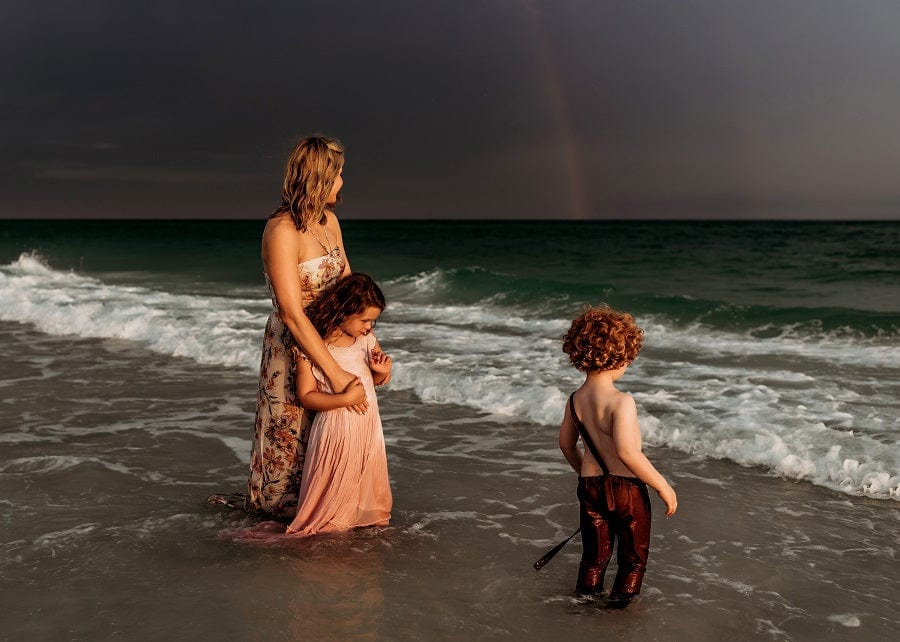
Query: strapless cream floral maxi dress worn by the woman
246 248 346 519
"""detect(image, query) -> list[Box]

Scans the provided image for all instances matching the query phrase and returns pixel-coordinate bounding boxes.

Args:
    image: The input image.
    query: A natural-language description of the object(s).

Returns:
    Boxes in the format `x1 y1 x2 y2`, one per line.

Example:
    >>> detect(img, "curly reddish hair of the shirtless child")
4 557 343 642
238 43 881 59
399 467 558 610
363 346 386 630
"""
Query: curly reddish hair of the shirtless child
563 303 644 374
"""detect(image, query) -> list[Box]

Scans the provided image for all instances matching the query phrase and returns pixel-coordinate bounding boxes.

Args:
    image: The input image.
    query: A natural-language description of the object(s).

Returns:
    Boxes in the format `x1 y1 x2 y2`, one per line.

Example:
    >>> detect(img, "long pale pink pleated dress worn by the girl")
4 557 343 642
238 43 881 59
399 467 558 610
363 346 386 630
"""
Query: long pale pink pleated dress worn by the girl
287 333 393 535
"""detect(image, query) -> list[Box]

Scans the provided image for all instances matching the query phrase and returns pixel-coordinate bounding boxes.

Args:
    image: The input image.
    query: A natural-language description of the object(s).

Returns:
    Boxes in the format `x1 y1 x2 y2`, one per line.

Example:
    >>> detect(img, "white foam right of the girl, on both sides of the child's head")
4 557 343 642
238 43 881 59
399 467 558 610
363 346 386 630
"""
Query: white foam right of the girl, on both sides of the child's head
383 296 900 499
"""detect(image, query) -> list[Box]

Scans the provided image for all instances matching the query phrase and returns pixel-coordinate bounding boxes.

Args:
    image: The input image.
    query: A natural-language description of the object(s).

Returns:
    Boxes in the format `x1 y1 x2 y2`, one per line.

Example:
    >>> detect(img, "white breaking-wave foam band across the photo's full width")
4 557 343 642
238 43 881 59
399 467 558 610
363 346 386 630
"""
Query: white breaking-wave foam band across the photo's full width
0 254 900 499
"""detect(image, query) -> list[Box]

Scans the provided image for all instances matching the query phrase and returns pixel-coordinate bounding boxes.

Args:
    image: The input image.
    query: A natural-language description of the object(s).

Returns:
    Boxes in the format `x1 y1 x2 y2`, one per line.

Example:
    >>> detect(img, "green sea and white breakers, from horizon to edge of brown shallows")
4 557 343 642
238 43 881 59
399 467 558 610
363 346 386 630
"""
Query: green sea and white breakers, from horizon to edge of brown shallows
0 221 900 501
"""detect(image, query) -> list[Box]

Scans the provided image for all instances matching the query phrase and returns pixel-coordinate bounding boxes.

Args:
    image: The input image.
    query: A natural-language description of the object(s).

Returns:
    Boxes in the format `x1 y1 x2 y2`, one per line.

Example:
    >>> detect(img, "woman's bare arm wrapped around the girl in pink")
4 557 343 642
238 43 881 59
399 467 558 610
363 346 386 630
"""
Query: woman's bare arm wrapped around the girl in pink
262 217 366 404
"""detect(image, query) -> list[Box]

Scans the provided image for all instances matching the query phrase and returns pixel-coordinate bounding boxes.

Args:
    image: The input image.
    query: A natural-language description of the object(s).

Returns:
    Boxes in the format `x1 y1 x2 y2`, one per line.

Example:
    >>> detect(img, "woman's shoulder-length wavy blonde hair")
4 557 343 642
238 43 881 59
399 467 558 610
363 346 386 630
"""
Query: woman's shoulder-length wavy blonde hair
272 134 344 232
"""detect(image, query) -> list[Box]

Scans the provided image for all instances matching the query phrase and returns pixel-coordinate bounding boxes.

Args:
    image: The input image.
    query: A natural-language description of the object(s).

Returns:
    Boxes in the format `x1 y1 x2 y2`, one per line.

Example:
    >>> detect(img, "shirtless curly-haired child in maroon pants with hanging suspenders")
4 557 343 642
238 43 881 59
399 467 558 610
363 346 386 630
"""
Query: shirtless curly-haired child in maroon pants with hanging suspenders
559 306 678 606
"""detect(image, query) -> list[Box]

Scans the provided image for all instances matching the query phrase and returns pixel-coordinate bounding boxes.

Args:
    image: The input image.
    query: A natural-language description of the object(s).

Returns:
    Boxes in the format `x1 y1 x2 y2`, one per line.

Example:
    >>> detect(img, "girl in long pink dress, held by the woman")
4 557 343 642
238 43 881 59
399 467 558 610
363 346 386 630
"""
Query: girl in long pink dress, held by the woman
287 273 393 535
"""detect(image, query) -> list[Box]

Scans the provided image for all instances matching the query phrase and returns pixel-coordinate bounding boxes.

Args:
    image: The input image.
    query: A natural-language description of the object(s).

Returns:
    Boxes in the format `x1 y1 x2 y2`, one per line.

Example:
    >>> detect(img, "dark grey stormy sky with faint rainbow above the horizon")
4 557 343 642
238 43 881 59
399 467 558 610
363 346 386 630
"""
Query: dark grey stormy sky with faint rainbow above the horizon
0 0 900 220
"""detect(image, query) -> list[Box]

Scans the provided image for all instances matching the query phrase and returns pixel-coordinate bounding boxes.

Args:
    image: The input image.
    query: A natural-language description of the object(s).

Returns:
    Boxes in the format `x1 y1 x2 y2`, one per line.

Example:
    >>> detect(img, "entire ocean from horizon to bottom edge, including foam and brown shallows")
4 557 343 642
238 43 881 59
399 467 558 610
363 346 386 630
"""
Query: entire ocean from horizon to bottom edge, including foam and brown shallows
0 220 900 641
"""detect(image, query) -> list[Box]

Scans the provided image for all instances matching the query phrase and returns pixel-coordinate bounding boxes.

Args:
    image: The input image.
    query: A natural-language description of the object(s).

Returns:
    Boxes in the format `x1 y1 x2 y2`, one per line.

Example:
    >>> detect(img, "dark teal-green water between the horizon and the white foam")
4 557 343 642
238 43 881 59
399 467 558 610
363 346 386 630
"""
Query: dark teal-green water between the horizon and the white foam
0 221 900 336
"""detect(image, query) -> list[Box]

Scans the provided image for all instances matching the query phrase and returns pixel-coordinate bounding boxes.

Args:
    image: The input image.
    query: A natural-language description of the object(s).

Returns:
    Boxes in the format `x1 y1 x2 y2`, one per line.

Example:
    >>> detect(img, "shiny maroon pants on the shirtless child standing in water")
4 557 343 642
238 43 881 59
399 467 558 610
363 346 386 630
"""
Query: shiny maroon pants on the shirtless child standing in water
575 475 650 598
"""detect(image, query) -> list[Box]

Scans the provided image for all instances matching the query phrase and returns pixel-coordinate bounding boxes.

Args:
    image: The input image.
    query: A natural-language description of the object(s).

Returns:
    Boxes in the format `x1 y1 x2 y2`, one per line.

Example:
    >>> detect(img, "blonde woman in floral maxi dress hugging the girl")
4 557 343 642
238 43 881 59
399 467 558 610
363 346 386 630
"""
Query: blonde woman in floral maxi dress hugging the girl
246 136 366 519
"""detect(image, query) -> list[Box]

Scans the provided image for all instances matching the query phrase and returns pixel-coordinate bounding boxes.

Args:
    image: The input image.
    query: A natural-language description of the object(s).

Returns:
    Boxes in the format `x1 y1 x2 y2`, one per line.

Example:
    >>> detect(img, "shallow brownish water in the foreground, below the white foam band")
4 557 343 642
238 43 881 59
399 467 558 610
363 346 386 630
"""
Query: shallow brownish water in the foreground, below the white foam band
0 322 900 641
